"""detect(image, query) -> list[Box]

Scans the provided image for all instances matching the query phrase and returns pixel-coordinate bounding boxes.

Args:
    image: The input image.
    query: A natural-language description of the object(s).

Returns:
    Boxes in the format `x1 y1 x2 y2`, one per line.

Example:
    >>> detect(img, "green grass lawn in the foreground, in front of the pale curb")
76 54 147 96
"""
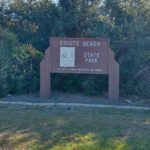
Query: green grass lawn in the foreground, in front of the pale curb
0 105 150 150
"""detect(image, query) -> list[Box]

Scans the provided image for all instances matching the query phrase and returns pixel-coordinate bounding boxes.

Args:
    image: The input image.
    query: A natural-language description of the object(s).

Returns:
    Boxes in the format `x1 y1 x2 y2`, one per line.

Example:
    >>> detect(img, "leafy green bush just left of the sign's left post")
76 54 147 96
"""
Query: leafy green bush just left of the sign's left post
0 29 42 96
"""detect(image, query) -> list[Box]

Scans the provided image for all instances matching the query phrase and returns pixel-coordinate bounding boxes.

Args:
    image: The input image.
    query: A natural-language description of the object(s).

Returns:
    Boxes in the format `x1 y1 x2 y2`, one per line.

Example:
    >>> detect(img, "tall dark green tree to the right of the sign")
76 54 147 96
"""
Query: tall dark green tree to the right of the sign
105 0 150 97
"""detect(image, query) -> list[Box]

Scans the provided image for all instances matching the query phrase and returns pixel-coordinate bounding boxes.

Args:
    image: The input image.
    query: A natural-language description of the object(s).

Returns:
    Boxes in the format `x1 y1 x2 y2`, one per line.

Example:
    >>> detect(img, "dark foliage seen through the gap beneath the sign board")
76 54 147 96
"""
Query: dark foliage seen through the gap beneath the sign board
52 74 108 95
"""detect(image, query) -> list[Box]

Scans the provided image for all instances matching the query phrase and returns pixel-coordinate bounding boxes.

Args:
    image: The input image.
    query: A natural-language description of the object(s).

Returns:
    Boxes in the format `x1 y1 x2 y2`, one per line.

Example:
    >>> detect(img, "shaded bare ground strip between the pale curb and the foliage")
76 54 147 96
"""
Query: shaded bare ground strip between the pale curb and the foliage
3 91 150 106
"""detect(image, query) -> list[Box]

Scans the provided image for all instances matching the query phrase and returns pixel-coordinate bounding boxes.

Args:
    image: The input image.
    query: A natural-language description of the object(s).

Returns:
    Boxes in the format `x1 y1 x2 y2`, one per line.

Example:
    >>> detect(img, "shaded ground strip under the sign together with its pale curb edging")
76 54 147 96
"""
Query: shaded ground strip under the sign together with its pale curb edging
0 91 150 108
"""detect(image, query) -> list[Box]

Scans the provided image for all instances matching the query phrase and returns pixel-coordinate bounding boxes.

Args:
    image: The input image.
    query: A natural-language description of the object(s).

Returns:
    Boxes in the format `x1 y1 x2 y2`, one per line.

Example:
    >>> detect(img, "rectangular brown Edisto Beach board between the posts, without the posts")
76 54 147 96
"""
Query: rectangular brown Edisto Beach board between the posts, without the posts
51 38 108 74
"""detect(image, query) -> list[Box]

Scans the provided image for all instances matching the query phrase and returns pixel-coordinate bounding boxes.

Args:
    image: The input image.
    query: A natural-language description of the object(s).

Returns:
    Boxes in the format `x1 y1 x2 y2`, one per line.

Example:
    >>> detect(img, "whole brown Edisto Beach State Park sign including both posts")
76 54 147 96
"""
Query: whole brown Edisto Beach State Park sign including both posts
40 37 119 100
